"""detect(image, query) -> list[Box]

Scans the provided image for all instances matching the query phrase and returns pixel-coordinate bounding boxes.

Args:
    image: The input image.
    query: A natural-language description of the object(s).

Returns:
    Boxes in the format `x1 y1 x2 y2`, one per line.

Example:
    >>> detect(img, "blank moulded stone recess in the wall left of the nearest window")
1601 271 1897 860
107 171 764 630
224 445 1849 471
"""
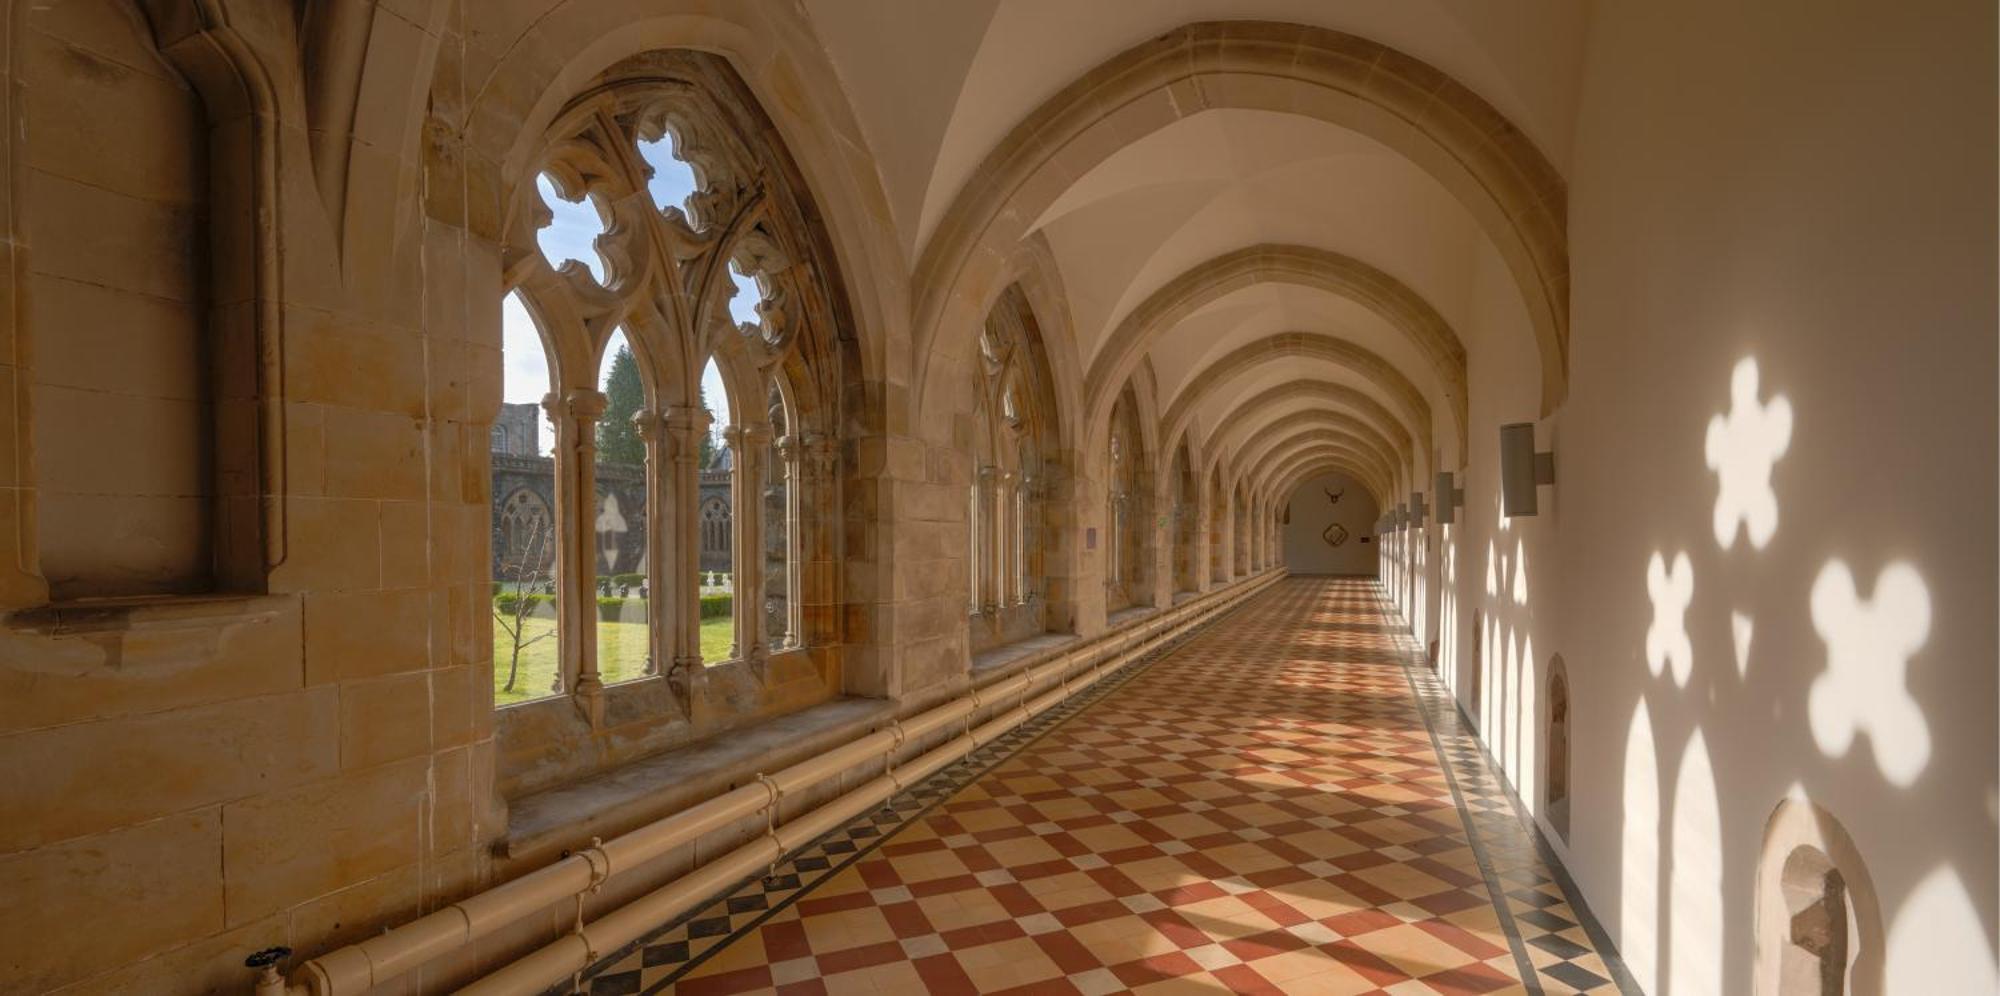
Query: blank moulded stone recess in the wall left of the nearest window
0 0 286 608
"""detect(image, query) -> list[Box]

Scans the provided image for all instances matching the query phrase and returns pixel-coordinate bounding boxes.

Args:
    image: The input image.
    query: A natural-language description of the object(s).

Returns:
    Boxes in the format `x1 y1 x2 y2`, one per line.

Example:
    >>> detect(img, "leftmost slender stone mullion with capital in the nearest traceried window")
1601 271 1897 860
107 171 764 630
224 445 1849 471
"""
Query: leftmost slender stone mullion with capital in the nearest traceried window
542 390 606 726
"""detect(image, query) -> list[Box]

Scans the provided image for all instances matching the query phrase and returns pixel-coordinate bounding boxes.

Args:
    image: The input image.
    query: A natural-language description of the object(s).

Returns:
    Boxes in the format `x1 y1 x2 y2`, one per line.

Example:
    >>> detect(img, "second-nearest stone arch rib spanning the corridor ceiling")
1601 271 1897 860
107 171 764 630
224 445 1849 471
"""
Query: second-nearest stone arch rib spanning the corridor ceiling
1084 244 1466 466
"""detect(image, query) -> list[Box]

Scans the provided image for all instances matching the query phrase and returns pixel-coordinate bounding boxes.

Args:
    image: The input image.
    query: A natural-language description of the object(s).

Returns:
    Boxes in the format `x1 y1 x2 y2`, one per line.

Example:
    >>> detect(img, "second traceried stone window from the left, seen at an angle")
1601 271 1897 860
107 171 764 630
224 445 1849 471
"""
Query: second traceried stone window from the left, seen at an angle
966 286 1070 654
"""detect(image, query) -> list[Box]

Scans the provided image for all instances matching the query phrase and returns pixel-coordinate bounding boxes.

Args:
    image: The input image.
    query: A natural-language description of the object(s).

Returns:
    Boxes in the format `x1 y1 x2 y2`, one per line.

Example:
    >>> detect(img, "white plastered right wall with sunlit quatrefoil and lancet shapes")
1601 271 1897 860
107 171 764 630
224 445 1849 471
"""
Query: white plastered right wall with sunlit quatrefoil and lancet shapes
1544 2 1996 992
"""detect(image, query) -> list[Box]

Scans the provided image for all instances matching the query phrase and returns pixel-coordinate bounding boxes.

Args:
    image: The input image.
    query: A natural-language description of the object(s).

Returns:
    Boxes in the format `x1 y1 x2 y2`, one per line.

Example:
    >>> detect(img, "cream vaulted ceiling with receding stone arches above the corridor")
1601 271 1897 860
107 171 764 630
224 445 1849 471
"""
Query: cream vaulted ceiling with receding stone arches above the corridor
806 0 1588 498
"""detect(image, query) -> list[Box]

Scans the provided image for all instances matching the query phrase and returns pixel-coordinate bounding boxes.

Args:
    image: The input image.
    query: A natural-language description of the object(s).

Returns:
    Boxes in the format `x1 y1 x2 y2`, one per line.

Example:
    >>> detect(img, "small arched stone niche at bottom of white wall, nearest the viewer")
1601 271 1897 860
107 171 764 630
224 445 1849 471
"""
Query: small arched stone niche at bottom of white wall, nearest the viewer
1754 794 1884 996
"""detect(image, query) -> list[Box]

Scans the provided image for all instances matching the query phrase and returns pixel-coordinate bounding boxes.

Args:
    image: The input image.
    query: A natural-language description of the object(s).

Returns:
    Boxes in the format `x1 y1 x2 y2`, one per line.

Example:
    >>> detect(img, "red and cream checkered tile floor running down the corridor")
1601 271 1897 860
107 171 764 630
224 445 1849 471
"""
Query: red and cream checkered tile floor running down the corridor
582 578 1636 996
